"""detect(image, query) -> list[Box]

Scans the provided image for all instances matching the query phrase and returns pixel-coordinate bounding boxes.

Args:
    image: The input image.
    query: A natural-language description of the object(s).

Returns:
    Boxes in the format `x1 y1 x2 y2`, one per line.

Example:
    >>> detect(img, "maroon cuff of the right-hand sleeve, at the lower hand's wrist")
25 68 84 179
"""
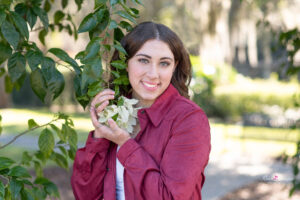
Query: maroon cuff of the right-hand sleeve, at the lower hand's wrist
117 138 140 166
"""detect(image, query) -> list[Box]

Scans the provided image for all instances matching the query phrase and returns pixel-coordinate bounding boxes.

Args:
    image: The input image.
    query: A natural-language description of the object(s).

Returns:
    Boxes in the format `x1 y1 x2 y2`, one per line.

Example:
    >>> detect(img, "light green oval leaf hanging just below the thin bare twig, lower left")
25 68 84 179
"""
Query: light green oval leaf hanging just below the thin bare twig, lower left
38 128 55 157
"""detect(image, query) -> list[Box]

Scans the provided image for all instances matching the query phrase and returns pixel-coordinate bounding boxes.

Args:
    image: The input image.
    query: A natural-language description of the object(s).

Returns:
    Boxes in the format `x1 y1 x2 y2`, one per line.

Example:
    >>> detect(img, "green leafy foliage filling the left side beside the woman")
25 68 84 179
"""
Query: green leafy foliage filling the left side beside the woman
0 0 141 199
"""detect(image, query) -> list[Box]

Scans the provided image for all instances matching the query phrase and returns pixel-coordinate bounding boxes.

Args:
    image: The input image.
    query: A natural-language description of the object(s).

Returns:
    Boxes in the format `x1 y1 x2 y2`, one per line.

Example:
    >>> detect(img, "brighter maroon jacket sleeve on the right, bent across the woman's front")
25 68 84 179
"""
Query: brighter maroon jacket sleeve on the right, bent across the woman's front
117 110 211 200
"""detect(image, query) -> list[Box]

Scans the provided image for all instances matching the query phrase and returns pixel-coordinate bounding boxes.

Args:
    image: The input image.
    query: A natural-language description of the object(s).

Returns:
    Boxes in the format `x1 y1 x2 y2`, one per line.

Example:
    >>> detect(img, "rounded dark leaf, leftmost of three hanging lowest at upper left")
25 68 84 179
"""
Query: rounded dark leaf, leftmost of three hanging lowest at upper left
7 52 26 82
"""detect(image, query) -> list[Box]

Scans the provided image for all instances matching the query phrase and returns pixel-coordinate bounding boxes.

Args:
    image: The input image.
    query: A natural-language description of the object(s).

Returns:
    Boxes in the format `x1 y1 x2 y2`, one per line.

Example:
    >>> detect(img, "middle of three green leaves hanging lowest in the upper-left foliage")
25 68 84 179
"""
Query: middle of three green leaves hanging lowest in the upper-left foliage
30 68 47 102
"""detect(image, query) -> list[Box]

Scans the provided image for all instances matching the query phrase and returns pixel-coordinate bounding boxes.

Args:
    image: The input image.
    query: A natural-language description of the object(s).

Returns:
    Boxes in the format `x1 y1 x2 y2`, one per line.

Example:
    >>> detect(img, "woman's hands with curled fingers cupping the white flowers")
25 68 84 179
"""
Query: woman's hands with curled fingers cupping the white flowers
90 89 130 146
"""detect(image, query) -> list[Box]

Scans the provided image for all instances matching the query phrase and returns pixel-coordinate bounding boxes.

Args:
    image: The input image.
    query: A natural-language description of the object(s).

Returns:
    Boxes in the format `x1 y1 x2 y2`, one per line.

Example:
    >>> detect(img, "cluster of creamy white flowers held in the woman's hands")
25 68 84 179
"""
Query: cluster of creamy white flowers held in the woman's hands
98 96 139 134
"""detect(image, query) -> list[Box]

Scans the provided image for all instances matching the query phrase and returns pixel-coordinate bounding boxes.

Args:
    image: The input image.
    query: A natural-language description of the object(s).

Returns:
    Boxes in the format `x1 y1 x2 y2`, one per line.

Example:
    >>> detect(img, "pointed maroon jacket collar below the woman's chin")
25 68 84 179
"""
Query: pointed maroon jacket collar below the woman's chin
140 83 180 127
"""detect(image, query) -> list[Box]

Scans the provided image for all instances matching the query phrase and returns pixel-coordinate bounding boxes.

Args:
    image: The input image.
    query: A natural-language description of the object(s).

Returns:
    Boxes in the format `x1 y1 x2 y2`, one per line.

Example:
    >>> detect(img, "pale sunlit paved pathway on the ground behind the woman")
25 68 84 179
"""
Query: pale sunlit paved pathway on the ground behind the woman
0 134 292 200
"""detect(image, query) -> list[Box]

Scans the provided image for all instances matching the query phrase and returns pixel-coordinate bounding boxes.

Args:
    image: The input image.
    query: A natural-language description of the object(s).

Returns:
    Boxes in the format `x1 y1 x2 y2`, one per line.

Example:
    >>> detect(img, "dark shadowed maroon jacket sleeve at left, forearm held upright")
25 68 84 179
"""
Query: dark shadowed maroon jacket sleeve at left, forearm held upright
71 131 110 200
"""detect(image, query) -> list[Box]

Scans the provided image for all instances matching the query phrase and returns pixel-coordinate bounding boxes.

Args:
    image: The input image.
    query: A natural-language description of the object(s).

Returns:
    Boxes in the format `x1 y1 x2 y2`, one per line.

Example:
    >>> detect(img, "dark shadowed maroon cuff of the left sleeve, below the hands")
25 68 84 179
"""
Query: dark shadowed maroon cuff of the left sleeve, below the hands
85 131 110 153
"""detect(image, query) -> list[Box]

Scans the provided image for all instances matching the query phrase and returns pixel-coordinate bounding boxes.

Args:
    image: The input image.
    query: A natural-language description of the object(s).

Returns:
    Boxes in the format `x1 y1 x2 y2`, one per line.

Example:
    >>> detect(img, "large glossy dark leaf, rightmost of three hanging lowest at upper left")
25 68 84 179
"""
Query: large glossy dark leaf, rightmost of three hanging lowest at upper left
42 57 65 100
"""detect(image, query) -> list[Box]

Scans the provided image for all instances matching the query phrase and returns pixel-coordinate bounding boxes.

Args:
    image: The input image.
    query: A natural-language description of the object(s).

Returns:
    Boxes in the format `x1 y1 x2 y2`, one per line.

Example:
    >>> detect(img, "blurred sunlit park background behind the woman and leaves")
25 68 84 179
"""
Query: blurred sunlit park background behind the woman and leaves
0 0 300 200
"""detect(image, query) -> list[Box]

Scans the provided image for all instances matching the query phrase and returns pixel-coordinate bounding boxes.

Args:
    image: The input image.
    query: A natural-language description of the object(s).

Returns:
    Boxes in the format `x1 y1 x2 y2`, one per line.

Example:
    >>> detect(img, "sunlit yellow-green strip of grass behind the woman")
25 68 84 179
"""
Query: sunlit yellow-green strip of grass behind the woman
0 109 300 161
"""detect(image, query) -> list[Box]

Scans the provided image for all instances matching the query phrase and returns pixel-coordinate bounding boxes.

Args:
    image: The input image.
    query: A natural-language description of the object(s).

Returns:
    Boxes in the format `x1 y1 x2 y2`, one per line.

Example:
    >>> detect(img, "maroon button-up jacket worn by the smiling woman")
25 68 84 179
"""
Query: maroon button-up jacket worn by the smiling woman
71 84 211 200
